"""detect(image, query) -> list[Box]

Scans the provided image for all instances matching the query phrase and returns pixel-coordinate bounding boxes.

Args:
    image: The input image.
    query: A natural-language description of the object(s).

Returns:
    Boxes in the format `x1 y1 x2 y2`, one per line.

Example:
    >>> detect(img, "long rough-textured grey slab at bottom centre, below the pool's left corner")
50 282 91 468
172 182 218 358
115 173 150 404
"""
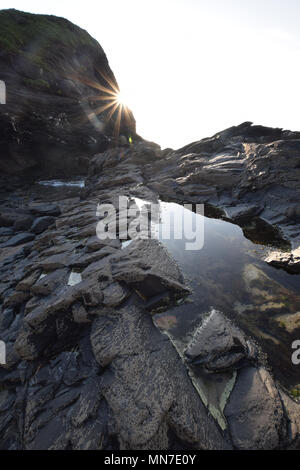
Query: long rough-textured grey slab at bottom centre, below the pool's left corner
91 307 230 450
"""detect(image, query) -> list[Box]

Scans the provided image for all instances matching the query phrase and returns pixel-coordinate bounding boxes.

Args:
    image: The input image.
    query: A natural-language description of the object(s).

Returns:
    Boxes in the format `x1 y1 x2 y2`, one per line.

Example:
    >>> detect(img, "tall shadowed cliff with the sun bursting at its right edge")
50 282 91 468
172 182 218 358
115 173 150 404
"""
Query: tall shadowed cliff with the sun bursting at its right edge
0 10 135 177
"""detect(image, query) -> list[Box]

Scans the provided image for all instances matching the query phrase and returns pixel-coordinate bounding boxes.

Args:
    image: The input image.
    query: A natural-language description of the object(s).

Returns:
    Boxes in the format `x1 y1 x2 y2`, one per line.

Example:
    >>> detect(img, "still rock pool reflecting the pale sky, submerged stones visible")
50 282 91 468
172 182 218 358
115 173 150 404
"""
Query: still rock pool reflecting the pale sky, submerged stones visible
136 200 300 389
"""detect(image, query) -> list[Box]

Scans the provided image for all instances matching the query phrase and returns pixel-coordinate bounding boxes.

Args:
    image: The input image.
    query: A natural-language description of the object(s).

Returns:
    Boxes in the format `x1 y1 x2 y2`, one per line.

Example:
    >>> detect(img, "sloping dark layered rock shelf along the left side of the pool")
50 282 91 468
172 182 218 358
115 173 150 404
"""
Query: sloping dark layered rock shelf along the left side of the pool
0 171 231 449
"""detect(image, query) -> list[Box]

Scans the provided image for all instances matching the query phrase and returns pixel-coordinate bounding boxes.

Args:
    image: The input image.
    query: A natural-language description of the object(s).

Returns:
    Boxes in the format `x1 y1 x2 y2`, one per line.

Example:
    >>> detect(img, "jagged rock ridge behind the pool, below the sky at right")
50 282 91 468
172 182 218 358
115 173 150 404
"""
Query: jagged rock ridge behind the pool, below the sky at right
145 122 300 269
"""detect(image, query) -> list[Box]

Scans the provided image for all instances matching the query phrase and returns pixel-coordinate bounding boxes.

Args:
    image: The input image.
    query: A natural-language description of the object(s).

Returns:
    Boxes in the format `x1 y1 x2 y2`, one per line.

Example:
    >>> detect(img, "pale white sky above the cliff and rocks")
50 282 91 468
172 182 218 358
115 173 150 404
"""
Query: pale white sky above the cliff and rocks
0 0 300 148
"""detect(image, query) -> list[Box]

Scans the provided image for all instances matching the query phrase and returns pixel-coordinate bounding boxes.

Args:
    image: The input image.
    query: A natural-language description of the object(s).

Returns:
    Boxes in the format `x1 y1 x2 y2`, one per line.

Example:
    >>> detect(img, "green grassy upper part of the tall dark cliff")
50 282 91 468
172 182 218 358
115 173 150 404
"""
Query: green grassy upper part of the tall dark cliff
0 10 110 96
